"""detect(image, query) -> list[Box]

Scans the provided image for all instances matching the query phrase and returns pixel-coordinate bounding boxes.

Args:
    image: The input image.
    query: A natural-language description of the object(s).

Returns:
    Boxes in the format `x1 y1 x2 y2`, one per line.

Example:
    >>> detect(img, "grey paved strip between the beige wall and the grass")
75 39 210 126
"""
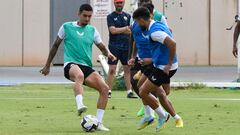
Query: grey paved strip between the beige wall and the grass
0 67 237 85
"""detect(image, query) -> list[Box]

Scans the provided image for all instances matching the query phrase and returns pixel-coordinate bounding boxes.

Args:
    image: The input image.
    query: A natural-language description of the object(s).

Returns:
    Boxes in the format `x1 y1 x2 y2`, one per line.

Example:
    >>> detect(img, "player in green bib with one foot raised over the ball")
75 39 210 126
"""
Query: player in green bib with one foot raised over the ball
40 4 116 131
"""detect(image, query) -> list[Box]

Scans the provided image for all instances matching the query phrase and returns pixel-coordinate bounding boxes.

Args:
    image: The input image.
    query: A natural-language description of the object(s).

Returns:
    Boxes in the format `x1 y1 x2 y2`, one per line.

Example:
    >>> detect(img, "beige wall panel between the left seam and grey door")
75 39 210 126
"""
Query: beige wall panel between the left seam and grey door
23 0 50 66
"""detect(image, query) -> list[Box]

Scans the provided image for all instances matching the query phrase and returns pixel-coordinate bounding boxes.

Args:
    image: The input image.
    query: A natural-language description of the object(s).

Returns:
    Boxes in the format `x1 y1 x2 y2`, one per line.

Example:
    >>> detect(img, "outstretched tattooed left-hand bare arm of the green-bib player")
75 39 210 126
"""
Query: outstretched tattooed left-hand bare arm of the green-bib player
40 36 62 76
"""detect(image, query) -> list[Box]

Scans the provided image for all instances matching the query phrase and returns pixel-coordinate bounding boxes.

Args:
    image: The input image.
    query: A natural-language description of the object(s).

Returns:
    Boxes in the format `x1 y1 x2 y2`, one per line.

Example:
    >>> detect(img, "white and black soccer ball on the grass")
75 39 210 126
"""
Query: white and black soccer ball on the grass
81 115 99 132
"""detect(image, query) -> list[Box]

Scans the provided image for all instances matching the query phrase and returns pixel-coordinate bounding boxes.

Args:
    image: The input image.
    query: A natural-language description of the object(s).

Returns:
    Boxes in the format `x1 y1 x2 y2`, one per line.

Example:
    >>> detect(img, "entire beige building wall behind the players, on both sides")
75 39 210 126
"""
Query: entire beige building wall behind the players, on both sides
0 0 237 66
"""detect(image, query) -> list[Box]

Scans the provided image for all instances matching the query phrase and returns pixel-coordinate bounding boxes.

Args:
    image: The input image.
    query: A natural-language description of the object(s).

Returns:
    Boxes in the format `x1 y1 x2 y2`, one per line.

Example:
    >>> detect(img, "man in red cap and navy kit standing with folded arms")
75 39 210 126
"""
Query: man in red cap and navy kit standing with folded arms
107 0 137 98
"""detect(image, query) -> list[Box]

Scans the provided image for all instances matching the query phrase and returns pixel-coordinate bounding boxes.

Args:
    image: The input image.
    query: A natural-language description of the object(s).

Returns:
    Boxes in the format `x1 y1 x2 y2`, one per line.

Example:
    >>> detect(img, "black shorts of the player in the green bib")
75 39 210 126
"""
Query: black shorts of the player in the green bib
64 62 95 80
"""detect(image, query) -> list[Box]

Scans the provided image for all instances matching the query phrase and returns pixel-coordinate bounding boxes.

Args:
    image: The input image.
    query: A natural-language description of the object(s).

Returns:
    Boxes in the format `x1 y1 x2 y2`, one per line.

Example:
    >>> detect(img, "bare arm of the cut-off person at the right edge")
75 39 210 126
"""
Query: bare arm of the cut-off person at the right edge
232 21 240 58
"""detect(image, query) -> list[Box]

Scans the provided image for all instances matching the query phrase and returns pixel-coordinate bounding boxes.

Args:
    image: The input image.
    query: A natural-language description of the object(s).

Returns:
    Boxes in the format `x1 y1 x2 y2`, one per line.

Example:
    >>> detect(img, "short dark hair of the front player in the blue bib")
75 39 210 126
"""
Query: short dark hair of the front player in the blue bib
133 7 151 20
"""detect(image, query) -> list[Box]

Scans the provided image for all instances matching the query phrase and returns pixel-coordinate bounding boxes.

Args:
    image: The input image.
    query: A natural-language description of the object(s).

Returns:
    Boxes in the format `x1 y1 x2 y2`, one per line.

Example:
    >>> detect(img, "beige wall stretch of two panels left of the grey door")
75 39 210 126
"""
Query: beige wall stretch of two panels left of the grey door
0 0 50 66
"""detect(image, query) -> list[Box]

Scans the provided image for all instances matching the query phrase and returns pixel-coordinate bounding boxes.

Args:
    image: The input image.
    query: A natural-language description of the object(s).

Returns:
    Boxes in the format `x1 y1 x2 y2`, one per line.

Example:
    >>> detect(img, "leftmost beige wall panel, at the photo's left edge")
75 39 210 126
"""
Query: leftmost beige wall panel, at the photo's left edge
0 0 23 66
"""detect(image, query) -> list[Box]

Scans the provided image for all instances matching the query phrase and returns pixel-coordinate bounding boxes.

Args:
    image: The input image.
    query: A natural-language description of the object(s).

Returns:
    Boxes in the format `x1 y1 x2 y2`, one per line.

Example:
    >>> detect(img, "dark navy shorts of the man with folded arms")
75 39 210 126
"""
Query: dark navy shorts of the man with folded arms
108 46 128 65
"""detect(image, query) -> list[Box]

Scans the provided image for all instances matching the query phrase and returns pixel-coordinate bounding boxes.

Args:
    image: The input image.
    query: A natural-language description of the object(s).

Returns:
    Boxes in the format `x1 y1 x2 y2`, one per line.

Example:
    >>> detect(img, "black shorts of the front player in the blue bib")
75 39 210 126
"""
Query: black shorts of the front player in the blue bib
148 67 177 86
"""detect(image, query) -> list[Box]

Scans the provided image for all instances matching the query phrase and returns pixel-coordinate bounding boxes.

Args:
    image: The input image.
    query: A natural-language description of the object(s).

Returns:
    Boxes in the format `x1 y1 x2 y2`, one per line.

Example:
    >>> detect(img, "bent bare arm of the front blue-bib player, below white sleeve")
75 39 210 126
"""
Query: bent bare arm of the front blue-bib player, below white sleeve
164 37 176 74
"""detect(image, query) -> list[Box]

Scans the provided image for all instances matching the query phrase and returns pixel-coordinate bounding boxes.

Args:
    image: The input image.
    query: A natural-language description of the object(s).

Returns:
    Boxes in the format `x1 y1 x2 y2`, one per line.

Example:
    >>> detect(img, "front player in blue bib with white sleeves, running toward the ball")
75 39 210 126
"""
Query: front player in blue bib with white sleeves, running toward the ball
133 7 183 131
